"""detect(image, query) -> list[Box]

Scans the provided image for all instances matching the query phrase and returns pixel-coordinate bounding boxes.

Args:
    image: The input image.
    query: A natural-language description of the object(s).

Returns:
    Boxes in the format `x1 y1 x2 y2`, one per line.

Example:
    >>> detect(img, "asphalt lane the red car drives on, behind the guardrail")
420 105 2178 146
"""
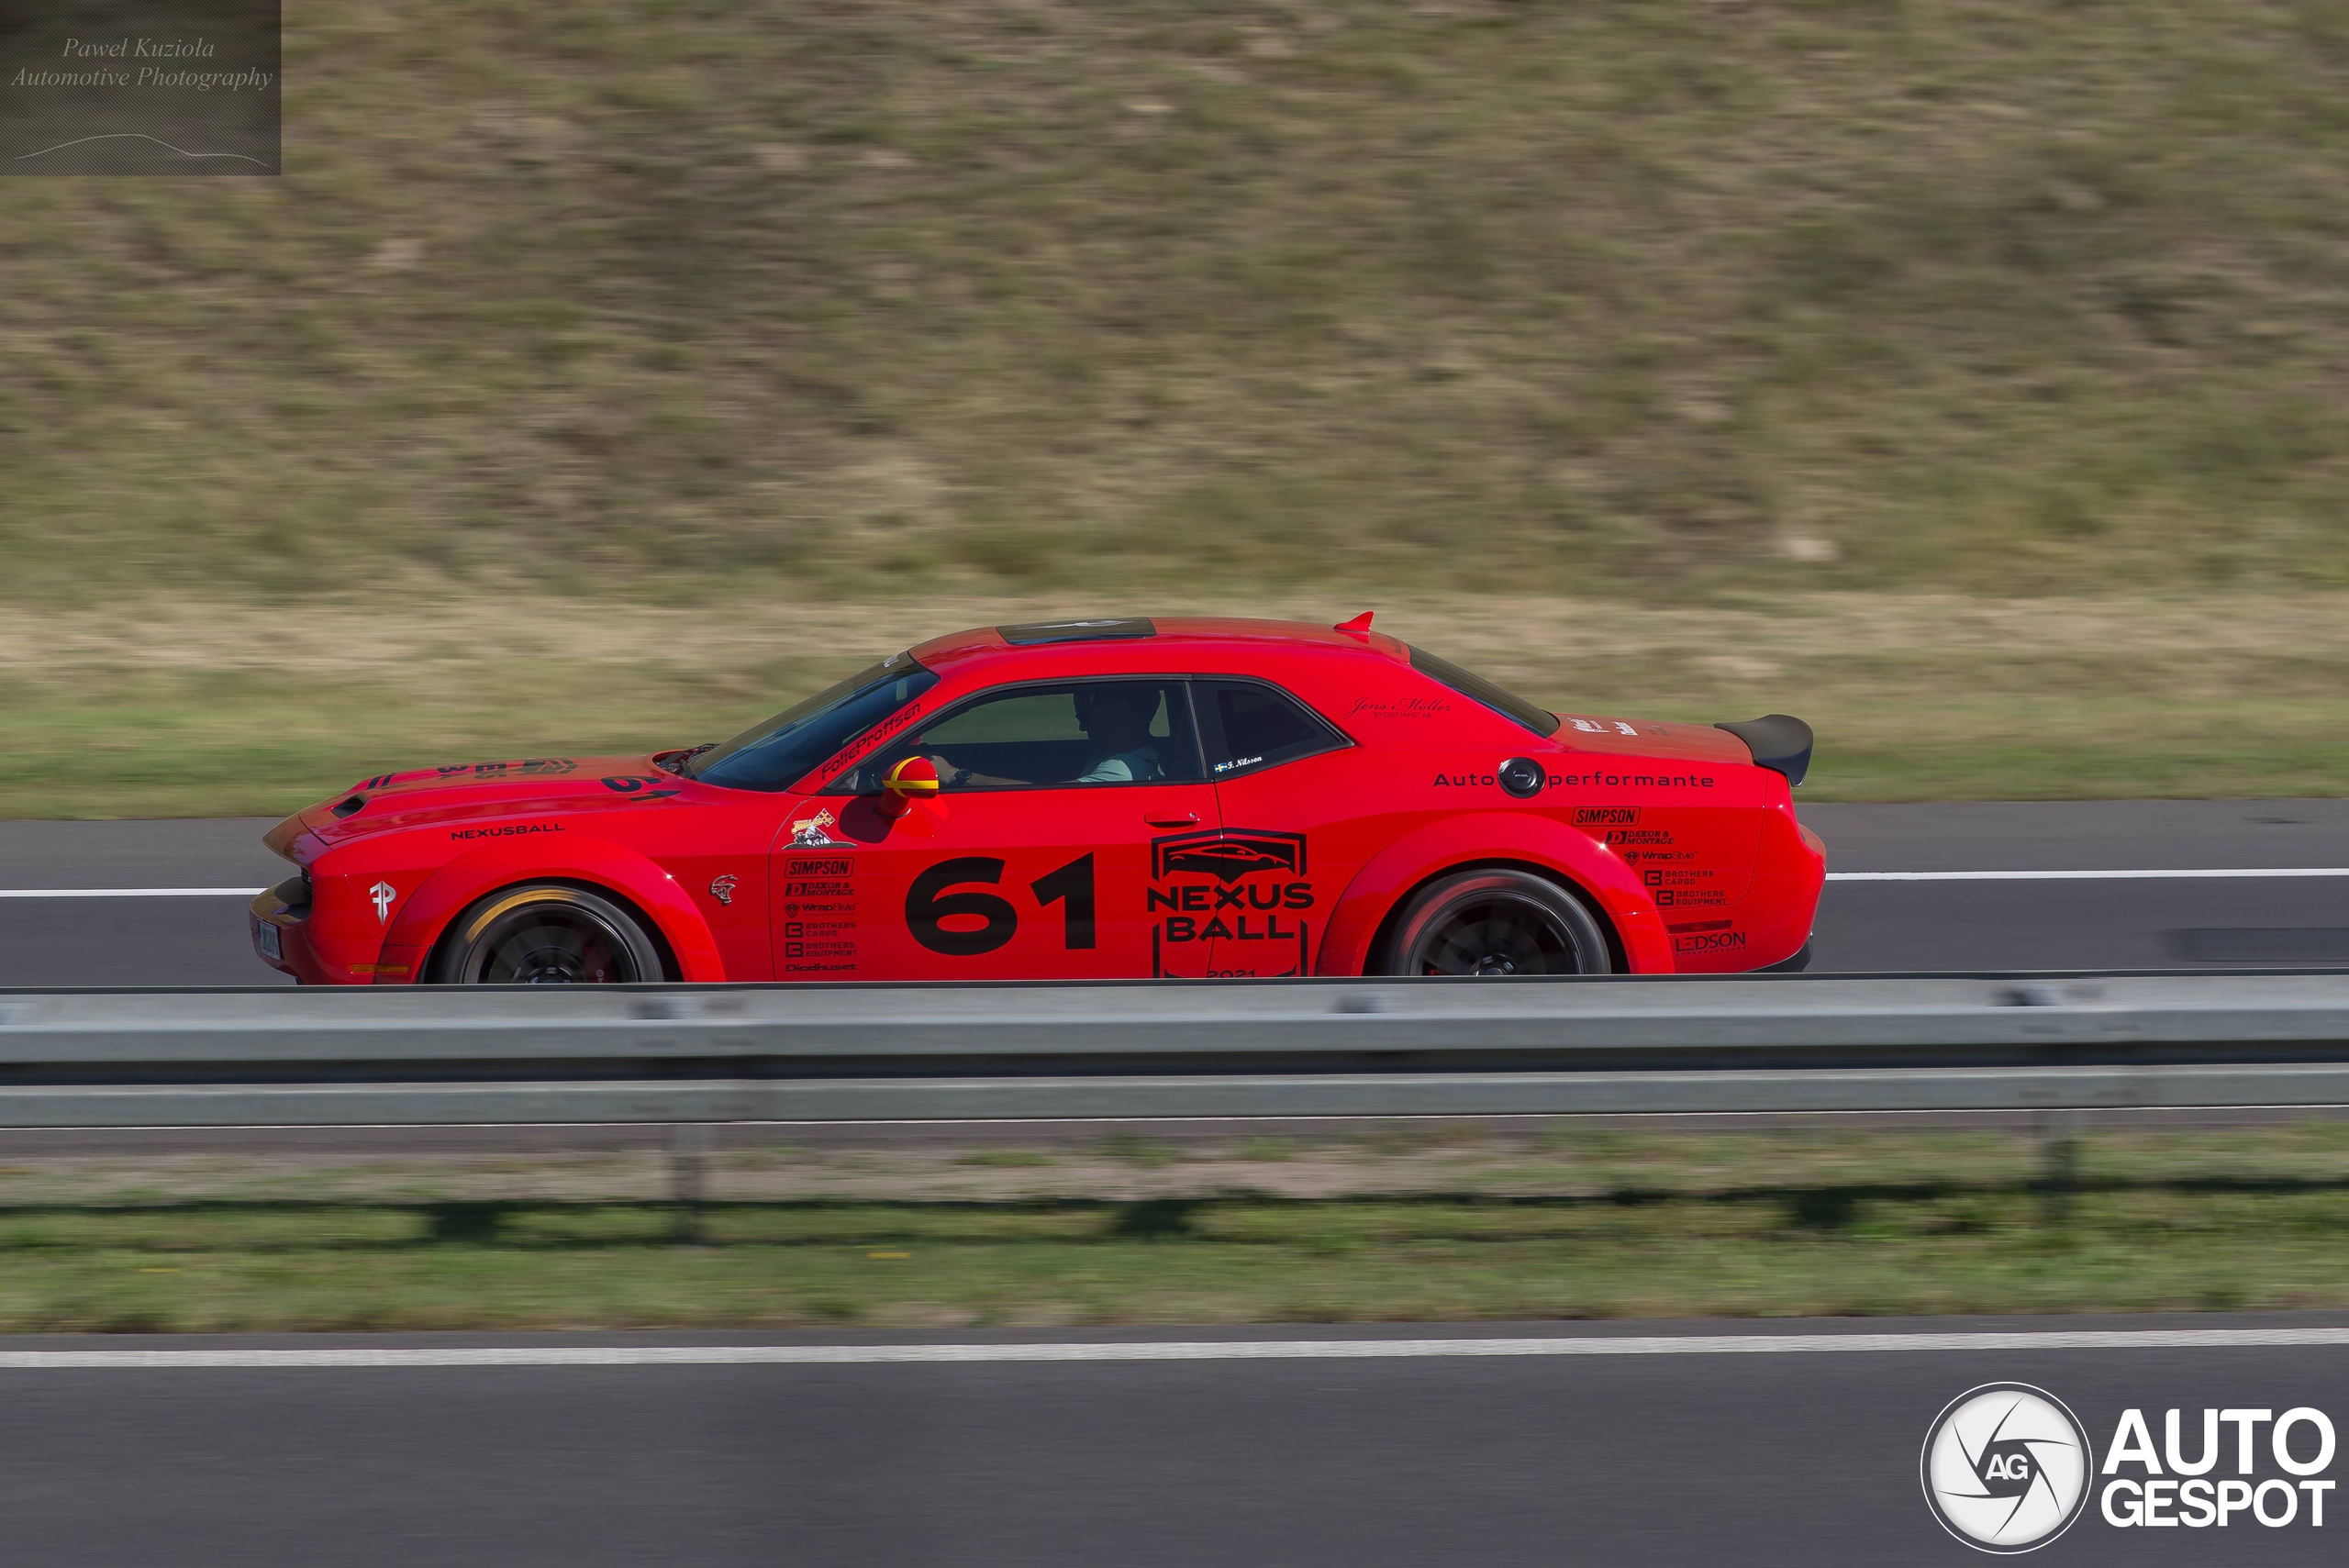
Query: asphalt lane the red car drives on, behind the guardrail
0 800 2349 986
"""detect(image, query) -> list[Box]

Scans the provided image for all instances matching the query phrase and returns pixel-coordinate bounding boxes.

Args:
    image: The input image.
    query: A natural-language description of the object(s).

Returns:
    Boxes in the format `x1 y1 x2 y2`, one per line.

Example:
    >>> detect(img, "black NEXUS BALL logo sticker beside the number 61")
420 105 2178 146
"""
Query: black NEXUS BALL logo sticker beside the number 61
1141 828 1313 979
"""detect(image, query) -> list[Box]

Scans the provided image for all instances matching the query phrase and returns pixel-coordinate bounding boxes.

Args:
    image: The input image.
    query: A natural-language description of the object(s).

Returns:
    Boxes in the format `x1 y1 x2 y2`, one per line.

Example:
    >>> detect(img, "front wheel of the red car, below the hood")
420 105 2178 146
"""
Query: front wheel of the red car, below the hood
432 883 667 986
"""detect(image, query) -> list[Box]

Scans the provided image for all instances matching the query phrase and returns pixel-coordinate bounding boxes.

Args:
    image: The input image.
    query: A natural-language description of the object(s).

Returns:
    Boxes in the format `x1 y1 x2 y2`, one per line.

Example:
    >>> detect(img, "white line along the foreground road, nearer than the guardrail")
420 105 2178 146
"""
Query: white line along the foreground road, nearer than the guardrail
0 1329 2349 1371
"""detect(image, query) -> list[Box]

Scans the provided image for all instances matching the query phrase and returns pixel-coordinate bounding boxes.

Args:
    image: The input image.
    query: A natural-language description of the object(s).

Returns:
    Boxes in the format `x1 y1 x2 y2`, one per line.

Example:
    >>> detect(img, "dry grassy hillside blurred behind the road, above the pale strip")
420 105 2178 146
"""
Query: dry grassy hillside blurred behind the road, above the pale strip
0 0 2349 613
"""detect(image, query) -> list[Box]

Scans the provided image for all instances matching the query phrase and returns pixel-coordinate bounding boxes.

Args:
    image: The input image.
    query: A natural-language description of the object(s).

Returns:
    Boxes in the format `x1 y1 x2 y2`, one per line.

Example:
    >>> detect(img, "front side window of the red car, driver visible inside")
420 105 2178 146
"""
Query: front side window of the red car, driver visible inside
825 681 1203 794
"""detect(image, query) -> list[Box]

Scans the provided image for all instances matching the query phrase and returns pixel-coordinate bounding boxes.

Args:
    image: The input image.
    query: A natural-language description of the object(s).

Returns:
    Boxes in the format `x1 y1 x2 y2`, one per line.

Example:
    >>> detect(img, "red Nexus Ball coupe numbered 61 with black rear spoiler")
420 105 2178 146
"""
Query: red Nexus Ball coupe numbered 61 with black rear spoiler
251 615 1825 986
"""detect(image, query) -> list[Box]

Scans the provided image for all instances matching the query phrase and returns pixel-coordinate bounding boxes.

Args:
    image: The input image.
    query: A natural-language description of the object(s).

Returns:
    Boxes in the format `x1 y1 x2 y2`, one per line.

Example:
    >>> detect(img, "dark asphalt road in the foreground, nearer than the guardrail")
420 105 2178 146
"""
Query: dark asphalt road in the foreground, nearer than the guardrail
0 1315 2349 1568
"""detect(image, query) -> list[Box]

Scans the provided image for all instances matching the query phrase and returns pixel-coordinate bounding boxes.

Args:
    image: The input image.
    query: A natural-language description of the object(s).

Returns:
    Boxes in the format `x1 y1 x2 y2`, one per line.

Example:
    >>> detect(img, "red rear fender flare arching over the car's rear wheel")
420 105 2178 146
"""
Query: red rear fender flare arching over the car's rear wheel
1313 812 1675 974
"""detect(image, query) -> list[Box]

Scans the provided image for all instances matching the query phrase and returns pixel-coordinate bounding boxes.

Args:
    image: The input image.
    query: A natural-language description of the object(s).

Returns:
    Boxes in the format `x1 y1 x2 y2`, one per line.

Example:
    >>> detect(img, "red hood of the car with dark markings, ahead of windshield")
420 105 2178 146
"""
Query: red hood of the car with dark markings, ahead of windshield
265 753 688 859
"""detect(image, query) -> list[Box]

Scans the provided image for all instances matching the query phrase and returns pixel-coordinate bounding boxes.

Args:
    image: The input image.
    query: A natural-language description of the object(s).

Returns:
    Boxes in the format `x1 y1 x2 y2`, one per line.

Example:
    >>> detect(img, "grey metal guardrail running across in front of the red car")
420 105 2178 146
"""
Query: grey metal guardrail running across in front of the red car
0 972 2349 1127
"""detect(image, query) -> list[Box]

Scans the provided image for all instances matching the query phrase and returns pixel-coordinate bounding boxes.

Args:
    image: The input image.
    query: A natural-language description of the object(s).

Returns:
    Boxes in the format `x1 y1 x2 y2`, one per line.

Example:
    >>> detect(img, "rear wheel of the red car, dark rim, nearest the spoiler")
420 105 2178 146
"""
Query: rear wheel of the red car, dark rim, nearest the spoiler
1379 869 1614 974
